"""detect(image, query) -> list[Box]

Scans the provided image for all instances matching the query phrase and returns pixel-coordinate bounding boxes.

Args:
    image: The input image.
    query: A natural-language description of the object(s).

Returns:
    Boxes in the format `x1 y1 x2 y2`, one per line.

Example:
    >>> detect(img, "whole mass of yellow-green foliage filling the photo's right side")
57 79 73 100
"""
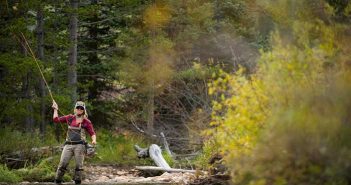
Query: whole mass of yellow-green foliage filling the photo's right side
208 0 351 184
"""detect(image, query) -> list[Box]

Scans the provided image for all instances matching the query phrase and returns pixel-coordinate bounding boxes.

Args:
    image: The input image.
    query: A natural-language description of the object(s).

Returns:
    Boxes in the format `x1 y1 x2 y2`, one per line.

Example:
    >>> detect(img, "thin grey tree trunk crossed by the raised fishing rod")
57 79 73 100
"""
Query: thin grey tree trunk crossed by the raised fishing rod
37 5 46 136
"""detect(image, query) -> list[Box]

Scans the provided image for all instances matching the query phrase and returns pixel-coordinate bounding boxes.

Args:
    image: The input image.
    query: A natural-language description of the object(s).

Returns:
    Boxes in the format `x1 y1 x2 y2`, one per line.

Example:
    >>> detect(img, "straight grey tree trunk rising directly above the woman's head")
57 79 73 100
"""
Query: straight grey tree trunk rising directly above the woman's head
68 0 78 102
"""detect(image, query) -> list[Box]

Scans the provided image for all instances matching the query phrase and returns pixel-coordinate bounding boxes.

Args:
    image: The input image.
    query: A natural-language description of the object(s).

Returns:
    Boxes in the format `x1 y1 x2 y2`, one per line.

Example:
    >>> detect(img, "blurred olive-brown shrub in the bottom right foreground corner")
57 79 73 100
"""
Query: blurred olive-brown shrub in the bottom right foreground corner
230 74 351 185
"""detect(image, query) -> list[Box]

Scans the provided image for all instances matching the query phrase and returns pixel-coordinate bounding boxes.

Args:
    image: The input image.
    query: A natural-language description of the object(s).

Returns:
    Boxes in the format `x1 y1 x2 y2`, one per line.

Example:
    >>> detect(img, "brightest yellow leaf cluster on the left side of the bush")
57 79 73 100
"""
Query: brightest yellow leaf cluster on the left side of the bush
207 69 269 158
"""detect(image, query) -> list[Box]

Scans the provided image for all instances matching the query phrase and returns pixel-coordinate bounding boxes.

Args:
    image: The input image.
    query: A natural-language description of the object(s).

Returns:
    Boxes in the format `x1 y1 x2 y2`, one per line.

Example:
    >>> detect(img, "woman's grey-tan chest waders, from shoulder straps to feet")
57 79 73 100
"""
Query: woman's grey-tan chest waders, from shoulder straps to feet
55 118 87 184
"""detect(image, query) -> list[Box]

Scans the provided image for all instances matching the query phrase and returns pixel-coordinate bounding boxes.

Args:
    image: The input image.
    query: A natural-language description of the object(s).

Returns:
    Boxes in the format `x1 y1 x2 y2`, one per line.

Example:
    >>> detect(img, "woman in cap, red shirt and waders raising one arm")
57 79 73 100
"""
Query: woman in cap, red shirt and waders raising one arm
52 101 96 184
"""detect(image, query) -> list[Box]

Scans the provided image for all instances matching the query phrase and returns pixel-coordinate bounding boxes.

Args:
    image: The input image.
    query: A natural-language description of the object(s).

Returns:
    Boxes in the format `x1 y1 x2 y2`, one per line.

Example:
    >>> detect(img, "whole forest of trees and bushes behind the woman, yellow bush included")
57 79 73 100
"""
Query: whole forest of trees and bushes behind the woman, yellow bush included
0 0 351 184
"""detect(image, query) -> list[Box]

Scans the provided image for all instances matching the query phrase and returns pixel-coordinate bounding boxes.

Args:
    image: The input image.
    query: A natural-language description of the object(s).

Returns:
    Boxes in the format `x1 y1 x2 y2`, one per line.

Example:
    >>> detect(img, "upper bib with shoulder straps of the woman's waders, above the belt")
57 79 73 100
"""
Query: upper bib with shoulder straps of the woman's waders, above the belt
66 115 86 144
